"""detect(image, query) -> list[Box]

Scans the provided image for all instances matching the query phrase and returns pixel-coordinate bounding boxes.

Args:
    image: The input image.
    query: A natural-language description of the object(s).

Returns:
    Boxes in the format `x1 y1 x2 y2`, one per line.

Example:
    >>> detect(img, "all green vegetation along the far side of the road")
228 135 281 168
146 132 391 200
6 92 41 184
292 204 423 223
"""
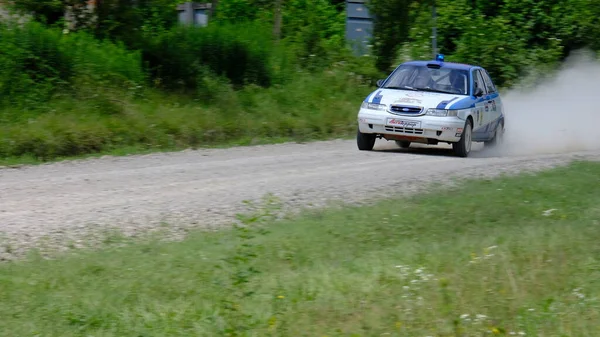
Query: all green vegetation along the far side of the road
0 0 600 159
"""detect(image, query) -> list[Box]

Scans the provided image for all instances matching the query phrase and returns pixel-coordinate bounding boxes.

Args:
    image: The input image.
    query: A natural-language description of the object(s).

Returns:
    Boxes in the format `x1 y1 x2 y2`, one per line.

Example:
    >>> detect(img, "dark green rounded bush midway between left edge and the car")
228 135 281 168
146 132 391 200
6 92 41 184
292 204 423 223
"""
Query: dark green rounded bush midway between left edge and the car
143 24 275 91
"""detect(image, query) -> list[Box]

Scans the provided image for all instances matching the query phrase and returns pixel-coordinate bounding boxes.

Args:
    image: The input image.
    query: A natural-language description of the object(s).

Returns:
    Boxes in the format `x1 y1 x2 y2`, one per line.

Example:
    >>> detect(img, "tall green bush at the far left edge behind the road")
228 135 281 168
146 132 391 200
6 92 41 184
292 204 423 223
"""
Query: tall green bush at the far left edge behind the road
0 22 145 117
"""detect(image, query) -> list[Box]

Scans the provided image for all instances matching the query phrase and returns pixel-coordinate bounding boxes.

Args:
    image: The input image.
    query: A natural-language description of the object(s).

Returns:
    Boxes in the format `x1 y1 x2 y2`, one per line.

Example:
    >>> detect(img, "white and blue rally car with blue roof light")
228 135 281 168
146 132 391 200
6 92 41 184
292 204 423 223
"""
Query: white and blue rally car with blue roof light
356 54 504 157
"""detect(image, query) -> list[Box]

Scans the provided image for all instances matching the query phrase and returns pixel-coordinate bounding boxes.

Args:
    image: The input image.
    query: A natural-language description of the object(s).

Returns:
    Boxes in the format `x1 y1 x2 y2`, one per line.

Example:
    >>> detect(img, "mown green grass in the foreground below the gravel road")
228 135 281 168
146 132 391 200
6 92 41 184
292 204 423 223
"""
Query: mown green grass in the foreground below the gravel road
0 162 600 336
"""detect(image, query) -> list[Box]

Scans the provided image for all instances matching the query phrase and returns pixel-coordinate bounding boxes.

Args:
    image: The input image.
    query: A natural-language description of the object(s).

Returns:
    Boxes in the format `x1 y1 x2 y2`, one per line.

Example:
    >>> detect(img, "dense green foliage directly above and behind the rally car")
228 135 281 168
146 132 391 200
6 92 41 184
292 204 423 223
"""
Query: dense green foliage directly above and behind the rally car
371 0 600 87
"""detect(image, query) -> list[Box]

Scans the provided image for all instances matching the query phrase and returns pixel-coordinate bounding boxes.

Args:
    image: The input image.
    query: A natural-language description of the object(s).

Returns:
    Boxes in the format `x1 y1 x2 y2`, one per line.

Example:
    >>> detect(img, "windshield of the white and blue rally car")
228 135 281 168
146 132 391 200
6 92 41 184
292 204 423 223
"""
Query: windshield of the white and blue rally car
383 65 469 95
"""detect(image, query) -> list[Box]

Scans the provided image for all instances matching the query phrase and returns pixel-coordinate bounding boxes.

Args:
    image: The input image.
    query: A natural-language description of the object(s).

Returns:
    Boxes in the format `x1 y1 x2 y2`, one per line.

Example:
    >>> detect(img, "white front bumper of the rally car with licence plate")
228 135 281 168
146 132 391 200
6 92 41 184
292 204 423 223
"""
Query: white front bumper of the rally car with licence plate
358 109 465 143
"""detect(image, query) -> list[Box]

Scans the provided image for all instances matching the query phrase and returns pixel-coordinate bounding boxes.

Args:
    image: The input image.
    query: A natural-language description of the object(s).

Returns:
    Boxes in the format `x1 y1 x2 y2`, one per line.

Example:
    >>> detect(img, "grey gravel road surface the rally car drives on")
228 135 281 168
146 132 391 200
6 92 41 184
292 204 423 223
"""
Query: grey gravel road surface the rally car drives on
0 140 600 258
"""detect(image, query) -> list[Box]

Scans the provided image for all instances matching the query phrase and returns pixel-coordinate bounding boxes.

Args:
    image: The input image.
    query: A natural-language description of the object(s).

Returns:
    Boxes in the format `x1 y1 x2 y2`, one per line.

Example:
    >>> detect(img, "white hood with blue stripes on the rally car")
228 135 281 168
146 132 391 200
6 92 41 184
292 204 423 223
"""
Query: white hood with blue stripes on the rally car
367 89 468 109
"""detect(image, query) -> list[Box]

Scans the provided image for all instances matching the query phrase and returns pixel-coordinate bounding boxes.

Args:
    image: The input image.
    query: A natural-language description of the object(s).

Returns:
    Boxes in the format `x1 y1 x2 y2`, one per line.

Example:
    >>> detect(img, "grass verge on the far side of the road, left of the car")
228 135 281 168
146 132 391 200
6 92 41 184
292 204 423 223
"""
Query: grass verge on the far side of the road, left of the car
0 69 372 165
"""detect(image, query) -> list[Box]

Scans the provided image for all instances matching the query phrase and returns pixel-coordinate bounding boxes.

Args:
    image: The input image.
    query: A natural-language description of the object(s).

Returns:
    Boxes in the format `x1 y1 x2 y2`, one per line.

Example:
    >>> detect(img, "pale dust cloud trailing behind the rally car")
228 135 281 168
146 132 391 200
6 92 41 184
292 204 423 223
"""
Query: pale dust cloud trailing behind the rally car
496 52 600 155
